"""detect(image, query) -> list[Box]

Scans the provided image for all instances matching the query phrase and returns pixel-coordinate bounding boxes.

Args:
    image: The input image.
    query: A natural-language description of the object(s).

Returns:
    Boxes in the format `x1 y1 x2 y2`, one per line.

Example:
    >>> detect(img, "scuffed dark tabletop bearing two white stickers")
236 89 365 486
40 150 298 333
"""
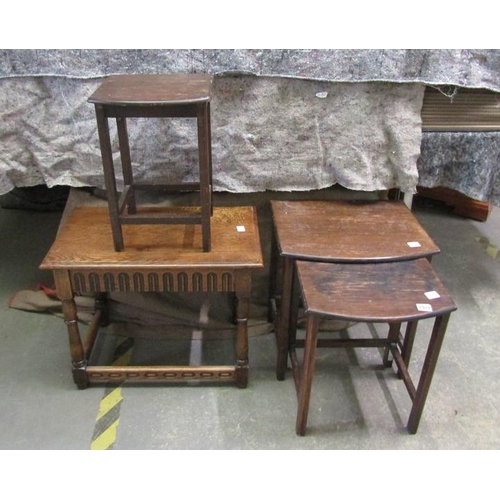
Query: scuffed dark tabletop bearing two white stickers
297 259 456 323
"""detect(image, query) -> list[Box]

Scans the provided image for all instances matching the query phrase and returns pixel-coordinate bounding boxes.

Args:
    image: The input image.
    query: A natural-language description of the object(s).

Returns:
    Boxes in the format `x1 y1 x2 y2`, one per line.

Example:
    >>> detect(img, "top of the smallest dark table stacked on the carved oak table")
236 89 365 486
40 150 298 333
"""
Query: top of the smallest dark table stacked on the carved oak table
88 73 212 106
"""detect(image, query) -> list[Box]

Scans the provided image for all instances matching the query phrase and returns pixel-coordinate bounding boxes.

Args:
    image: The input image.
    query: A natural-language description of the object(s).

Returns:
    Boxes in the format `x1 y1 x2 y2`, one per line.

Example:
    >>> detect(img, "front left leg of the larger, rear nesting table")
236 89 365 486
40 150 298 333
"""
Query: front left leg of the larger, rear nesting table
276 257 294 380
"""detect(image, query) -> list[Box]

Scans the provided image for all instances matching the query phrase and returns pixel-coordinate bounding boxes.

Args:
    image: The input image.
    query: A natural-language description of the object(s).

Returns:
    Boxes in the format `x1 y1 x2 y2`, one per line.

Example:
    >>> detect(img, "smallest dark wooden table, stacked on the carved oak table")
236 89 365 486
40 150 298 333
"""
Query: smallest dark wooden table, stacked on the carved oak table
88 74 213 252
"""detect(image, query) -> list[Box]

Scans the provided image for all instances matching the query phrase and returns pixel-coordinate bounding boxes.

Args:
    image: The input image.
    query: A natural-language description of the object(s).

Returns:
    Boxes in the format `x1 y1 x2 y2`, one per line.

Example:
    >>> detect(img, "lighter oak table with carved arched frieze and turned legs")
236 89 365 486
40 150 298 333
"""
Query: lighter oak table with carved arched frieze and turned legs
40 207 263 389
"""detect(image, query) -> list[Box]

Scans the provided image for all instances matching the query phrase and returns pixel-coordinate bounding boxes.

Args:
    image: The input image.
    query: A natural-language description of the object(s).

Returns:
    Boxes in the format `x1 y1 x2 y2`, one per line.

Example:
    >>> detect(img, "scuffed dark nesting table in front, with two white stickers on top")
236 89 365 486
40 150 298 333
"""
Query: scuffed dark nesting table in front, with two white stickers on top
290 259 456 435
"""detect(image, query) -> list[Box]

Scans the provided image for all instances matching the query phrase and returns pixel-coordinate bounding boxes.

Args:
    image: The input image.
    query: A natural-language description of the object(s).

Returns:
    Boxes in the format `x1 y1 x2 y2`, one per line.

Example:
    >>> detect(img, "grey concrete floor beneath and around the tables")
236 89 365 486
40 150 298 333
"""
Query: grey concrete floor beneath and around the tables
0 195 500 450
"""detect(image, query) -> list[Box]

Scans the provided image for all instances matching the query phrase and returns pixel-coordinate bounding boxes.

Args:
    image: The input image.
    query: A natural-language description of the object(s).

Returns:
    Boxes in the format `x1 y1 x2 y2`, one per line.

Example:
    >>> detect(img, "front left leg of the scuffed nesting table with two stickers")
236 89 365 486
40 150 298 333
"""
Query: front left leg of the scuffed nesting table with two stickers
295 315 319 436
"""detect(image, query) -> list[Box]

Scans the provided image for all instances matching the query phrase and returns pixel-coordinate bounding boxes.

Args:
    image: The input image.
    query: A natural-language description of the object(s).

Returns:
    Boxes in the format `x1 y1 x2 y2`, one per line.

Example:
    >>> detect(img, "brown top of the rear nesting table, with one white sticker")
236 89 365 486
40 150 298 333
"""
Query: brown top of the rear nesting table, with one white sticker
271 200 440 262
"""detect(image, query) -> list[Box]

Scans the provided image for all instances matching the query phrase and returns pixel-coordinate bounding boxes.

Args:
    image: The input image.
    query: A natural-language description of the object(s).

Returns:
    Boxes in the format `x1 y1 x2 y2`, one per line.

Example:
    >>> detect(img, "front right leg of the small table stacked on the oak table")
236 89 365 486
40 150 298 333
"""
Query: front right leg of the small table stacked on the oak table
197 104 212 252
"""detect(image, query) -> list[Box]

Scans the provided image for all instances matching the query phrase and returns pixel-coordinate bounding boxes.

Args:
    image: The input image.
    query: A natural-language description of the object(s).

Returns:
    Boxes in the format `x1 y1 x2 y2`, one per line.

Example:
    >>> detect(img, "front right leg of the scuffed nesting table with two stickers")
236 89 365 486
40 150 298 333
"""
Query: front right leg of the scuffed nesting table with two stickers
407 313 450 434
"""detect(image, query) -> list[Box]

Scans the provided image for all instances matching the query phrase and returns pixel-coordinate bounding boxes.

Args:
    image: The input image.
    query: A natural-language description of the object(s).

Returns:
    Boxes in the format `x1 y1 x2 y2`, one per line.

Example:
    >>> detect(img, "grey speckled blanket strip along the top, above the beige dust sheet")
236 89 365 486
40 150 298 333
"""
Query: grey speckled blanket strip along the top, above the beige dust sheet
0 49 500 91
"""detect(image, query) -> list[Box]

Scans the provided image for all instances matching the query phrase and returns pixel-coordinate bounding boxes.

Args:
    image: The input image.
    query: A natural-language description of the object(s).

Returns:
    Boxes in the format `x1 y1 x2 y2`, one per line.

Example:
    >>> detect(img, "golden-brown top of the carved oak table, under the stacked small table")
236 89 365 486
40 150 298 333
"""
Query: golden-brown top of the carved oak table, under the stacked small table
40 207 263 270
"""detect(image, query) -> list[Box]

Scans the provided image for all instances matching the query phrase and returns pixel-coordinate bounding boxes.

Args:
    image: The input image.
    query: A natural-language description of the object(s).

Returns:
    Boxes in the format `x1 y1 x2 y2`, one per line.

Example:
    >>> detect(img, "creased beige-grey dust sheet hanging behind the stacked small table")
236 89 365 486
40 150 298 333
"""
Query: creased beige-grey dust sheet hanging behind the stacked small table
0 76 424 194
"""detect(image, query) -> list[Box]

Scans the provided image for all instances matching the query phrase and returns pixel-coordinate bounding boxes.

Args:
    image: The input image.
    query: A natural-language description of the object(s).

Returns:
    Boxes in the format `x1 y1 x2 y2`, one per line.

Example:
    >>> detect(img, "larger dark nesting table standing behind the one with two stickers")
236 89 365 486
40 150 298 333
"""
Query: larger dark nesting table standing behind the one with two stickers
270 200 440 380
